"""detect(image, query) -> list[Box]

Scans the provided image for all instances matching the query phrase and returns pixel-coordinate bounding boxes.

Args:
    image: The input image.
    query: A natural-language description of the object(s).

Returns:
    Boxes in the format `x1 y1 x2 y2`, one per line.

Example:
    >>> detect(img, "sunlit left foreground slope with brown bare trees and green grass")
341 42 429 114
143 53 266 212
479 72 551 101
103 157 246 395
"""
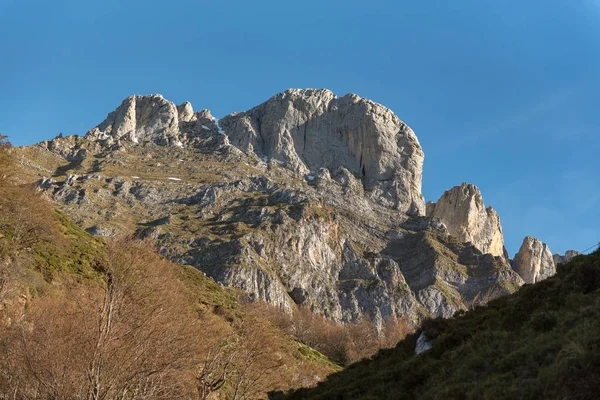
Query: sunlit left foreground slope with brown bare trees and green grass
0 138 339 399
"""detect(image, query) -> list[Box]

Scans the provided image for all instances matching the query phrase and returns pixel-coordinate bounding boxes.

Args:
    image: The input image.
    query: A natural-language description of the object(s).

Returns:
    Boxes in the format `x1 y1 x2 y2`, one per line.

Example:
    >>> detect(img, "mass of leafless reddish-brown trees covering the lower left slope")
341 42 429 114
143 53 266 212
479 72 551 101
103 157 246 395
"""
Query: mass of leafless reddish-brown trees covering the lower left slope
0 238 332 400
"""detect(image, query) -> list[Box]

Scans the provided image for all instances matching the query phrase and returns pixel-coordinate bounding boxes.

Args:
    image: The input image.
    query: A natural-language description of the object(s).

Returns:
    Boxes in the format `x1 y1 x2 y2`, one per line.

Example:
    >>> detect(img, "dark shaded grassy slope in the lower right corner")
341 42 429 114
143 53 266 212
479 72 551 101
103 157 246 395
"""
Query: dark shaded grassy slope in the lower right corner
280 250 600 399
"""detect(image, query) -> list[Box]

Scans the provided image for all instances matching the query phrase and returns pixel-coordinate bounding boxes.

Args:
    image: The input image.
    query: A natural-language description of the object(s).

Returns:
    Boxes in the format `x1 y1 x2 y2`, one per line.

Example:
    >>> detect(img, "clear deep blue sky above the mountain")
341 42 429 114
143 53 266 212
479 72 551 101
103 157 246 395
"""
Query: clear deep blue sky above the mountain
0 0 600 255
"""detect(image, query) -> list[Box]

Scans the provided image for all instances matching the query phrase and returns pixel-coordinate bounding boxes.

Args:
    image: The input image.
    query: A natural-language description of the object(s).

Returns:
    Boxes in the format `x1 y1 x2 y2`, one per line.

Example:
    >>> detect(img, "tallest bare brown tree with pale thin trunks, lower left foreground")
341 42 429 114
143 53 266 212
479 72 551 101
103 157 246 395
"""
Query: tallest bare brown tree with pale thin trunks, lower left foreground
80 239 199 400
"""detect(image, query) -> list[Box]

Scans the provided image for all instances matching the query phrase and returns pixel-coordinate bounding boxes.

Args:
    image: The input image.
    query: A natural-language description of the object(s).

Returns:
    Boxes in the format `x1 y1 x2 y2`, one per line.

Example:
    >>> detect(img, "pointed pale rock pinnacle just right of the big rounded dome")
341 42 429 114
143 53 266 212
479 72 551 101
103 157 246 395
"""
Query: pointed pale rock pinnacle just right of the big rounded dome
427 183 505 257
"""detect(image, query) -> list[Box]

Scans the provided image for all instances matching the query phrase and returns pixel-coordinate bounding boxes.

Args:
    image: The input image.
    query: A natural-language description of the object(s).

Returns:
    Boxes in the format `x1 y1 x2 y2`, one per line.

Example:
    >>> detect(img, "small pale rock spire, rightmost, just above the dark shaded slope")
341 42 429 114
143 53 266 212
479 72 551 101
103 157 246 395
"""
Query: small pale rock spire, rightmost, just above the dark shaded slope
513 236 556 283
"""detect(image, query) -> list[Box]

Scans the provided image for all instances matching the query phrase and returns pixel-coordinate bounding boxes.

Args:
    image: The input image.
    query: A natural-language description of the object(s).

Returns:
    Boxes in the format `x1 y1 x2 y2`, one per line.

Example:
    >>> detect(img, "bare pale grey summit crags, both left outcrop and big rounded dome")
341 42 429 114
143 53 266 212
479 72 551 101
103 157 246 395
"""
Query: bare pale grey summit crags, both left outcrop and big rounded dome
76 89 425 215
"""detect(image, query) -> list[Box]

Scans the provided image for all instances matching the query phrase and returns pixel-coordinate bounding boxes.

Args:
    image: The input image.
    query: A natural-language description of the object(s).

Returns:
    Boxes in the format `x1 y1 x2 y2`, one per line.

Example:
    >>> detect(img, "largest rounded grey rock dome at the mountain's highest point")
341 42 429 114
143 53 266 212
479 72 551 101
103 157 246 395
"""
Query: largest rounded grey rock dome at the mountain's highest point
221 89 425 215
